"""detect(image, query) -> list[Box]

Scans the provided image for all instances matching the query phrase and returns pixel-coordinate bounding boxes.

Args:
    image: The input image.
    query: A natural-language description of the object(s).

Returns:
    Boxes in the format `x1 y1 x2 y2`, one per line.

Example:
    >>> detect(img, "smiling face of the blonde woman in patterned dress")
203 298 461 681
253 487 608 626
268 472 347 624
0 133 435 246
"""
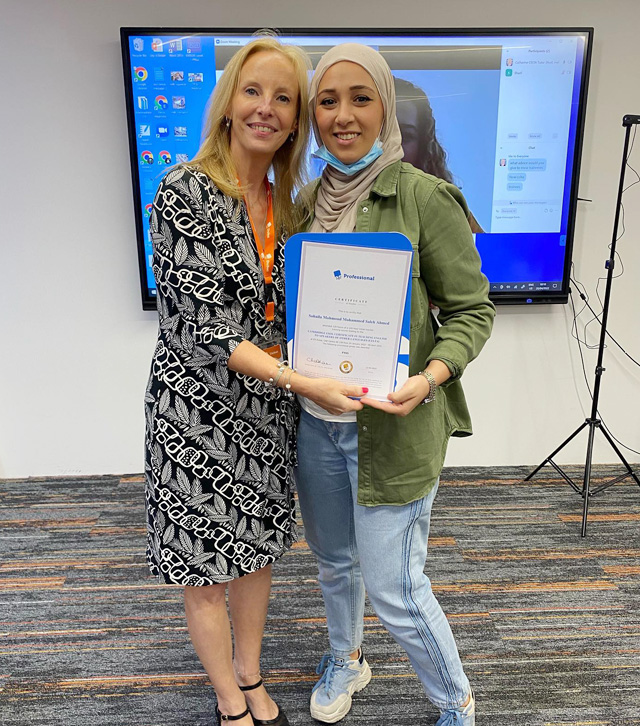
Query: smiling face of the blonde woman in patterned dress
227 51 299 168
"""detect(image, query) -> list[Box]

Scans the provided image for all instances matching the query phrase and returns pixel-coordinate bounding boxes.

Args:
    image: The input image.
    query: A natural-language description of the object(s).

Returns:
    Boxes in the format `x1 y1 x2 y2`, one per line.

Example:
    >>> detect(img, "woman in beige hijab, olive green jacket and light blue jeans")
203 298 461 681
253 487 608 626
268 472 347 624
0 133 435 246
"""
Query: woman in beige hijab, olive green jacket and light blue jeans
294 43 495 726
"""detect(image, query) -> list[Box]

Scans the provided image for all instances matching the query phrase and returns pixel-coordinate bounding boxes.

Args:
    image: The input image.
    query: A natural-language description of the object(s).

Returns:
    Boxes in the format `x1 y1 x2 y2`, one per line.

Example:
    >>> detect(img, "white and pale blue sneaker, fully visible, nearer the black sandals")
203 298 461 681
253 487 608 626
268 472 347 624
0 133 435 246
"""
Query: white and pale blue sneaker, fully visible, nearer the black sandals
310 651 371 723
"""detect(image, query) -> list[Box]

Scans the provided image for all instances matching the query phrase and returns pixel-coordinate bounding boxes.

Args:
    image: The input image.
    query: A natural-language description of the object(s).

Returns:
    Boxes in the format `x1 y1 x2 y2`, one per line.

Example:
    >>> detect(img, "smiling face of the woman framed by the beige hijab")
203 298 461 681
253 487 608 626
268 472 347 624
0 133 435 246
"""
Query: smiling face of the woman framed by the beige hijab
314 61 384 164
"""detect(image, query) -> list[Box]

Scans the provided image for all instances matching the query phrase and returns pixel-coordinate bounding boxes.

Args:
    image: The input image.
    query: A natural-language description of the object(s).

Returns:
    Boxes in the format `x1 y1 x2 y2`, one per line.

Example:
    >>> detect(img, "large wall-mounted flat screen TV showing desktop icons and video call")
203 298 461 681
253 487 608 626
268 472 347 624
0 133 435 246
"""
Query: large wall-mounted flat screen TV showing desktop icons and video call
121 28 593 309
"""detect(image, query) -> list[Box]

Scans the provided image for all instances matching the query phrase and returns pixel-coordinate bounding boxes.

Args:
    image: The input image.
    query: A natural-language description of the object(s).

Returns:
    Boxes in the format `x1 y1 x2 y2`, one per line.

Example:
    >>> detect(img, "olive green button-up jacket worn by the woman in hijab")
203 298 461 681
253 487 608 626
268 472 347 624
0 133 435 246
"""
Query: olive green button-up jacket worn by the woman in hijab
300 161 495 506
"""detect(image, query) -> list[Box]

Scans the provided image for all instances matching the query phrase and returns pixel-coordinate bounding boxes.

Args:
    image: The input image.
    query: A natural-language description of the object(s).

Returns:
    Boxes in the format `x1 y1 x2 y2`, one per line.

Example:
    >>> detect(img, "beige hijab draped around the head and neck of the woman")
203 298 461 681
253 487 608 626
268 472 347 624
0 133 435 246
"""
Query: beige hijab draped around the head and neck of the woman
309 43 404 232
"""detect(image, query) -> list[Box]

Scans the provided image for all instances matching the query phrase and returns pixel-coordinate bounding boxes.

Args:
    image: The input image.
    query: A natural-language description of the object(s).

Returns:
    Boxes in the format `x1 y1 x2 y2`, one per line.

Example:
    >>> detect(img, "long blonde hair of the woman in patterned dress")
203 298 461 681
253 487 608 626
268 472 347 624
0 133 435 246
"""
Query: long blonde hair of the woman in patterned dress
188 36 311 234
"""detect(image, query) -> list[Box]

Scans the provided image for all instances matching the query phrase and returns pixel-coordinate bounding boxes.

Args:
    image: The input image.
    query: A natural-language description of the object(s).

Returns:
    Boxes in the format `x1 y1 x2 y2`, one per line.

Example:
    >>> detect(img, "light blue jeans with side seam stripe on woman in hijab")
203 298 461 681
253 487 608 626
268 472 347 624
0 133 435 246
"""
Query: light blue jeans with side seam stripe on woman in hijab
298 411 470 712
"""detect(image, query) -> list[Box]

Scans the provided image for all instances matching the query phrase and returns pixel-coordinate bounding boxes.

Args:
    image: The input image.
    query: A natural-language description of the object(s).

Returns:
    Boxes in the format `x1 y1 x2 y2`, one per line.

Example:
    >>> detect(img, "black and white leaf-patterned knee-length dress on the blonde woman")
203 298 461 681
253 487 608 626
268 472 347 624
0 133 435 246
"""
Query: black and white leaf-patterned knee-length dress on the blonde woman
145 168 296 585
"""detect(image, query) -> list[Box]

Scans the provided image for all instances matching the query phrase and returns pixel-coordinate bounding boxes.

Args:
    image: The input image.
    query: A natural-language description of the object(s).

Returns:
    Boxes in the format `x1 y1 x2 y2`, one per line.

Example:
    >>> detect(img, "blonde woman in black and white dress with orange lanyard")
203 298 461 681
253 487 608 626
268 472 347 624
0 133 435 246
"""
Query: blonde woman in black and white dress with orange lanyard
145 38 362 726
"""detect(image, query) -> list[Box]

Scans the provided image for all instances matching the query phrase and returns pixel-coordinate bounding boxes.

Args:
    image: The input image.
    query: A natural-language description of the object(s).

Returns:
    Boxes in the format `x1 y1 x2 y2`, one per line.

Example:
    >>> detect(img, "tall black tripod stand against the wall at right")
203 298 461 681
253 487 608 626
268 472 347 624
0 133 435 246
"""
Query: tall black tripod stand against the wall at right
525 114 640 537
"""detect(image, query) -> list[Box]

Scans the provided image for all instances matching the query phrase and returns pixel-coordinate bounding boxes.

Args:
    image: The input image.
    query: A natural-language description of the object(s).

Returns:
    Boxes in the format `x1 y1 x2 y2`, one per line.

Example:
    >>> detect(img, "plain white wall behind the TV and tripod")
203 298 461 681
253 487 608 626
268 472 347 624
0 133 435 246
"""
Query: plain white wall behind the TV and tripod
0 0 640 477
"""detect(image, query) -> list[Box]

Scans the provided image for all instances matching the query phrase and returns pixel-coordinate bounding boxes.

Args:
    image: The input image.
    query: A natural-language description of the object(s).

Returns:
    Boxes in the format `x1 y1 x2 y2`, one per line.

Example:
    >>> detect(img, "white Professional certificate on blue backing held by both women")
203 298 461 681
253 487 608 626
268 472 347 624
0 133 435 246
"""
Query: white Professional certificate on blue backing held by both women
285 232 413 401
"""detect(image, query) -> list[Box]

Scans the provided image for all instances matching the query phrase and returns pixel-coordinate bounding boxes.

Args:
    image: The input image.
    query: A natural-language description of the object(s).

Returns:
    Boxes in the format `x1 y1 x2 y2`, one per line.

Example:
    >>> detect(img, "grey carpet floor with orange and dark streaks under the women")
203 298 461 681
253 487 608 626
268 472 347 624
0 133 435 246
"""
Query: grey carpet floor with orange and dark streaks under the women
0 467 640 726
